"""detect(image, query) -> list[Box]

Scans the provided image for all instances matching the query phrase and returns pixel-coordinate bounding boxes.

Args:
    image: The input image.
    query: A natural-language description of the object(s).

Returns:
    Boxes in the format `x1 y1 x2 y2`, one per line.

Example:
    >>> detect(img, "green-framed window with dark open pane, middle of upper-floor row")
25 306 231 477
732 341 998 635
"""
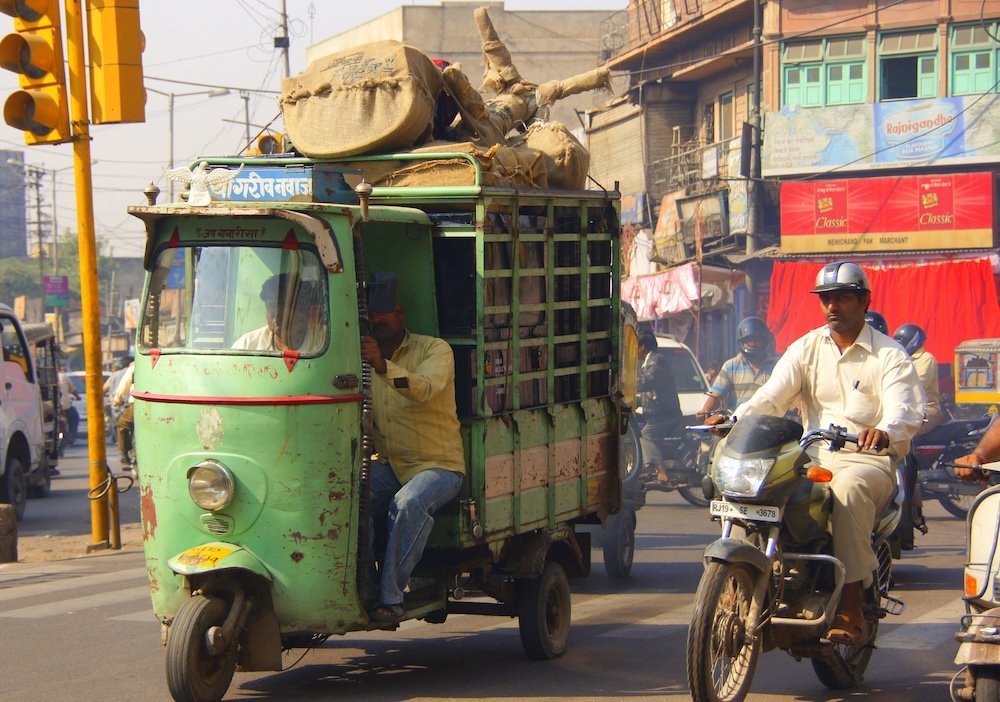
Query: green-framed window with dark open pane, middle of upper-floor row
878 28 938 100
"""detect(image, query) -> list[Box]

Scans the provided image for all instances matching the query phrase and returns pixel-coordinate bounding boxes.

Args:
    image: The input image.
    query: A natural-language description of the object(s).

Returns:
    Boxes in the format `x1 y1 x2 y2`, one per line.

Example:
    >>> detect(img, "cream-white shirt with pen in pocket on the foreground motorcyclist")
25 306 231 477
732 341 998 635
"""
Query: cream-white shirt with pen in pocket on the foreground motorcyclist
734 324 924 459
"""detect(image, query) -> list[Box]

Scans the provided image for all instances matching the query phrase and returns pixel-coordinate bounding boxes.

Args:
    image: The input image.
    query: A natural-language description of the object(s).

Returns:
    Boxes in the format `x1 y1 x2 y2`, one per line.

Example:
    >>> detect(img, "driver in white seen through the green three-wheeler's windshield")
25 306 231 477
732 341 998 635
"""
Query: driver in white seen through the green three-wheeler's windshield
231 272 325 353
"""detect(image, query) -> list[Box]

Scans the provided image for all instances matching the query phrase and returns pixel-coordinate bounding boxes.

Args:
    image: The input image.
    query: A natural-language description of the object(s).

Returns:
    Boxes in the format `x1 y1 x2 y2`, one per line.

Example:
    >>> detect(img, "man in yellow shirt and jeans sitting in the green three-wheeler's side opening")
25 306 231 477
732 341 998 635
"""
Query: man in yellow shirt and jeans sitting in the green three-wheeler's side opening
361 271 465 624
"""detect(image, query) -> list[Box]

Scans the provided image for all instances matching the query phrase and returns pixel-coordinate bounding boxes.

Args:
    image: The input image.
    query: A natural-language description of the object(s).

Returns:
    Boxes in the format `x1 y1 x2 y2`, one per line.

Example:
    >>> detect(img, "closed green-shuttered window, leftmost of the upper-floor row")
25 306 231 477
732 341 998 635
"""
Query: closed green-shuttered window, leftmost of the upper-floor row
781 35 868 107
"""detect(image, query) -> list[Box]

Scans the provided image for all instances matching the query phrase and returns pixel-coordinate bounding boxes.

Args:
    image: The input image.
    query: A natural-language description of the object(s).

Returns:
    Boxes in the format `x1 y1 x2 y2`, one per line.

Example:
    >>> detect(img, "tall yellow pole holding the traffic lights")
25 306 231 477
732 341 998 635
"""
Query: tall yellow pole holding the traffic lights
66 0 121 551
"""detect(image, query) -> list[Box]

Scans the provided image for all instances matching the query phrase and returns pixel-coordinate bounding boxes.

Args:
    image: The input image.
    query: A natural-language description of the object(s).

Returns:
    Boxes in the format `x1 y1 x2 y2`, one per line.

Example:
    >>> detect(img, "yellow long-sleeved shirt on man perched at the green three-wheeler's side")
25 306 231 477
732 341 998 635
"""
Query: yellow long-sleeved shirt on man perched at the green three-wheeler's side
372 332 465 484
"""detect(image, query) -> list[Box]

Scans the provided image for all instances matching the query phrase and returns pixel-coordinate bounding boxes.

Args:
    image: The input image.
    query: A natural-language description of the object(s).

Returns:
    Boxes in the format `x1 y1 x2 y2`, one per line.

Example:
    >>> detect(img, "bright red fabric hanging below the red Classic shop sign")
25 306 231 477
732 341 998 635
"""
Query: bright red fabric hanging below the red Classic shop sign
767 258 1000 363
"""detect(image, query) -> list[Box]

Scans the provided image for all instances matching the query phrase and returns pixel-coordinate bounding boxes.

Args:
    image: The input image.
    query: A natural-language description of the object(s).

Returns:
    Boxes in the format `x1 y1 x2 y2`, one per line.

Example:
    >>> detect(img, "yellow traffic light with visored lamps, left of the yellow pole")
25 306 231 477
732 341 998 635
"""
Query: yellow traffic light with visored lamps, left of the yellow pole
0 0 73 146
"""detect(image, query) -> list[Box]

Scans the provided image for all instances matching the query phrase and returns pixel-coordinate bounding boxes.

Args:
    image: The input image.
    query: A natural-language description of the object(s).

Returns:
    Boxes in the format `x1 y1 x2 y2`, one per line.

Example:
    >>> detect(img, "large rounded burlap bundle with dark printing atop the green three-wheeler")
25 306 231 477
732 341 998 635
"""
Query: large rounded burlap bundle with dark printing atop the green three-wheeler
281 41 441 158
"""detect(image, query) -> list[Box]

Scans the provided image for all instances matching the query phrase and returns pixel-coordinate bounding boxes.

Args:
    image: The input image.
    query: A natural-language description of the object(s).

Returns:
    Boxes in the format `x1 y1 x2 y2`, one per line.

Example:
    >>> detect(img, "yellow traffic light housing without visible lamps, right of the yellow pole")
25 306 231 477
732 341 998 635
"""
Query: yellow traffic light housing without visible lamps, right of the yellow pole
87 0 146 124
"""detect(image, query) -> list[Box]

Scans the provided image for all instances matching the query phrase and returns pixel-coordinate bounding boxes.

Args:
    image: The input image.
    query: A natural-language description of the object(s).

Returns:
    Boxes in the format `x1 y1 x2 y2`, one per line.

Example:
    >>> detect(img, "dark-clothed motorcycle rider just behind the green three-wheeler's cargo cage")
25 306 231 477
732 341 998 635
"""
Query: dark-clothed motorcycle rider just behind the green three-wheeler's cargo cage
636 330 684 482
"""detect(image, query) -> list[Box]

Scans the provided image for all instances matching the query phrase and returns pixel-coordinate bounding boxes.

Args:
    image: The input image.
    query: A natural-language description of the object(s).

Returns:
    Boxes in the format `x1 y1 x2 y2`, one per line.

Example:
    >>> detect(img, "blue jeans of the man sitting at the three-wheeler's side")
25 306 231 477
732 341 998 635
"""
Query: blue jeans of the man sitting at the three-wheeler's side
369 461 462 605
